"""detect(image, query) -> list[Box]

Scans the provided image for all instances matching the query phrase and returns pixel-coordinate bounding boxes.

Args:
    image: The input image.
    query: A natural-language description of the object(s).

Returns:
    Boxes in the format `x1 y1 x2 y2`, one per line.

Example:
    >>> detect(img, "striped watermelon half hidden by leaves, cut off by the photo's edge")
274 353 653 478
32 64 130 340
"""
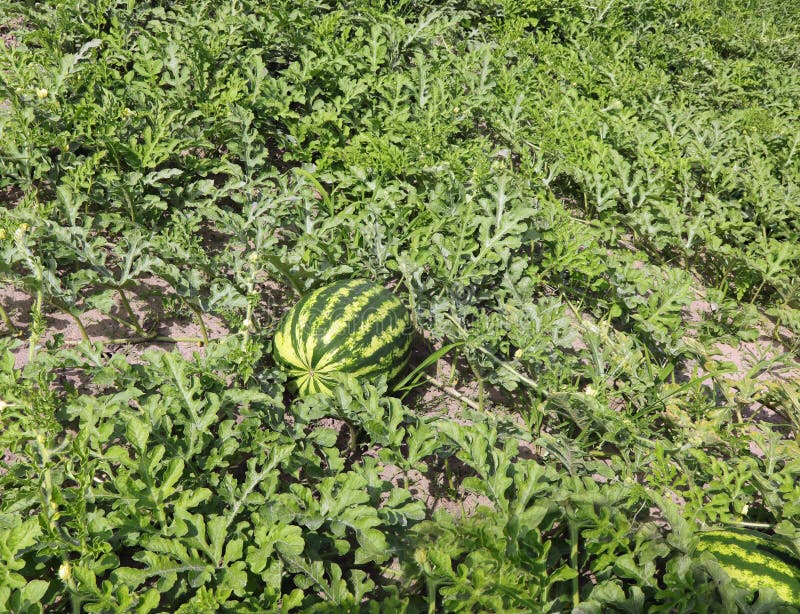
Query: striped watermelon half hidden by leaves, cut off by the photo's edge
695 529 800 605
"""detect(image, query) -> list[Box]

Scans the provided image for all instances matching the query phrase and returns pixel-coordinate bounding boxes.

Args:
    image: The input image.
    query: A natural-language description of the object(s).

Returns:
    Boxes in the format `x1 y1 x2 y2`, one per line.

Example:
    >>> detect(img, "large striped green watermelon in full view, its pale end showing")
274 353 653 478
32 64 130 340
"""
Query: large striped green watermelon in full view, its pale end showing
274 279 411 396
